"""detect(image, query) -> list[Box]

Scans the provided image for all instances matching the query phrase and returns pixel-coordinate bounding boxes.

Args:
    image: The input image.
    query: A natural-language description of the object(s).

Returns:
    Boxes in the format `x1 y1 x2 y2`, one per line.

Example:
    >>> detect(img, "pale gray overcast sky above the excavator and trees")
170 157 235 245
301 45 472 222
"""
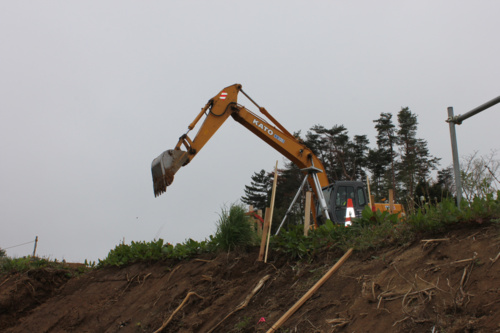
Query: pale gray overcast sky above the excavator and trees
0 0 500 261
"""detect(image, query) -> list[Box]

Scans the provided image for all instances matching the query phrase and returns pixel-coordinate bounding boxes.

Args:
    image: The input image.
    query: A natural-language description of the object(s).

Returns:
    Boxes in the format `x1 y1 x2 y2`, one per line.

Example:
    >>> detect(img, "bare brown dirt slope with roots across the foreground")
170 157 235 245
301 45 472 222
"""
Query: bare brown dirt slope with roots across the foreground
0 223 500 333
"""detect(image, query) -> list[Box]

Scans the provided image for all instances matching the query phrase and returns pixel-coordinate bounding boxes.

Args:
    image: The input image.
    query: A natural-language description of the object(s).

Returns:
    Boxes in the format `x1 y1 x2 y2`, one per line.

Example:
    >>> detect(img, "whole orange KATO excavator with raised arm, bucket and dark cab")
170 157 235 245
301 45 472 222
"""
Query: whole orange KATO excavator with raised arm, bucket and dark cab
151 84 394 226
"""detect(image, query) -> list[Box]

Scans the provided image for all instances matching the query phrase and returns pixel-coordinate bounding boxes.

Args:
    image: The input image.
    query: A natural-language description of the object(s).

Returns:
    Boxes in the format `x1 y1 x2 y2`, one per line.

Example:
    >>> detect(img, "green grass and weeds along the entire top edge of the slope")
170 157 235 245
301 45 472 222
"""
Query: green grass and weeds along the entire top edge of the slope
4 193 500 274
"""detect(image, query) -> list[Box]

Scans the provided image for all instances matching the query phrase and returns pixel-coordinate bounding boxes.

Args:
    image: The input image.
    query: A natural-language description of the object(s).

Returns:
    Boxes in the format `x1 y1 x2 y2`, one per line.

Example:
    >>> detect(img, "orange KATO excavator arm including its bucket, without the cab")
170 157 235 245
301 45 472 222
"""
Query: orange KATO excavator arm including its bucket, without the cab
151 84 328 220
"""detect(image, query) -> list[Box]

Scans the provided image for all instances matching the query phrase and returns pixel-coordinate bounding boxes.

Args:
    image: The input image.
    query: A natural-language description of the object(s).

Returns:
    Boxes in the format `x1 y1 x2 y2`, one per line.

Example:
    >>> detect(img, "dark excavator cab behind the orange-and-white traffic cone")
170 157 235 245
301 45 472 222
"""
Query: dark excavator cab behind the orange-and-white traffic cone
317 181 368 225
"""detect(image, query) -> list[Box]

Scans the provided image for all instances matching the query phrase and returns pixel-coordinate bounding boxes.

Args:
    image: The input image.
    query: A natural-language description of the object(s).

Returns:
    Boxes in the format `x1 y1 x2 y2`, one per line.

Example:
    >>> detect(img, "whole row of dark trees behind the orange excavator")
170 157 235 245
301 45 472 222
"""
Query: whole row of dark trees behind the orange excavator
241 107 454 226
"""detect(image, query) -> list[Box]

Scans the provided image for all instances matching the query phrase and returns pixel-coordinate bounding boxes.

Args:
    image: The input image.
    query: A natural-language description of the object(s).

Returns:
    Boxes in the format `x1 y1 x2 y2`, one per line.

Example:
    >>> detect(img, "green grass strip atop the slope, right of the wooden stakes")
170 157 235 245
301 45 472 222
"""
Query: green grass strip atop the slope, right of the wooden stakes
272 191 500 260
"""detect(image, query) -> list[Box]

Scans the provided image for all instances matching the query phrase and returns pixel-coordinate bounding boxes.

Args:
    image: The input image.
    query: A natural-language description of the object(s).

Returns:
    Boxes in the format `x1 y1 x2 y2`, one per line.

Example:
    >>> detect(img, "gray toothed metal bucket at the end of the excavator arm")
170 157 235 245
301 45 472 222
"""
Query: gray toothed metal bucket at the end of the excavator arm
151 149 189 197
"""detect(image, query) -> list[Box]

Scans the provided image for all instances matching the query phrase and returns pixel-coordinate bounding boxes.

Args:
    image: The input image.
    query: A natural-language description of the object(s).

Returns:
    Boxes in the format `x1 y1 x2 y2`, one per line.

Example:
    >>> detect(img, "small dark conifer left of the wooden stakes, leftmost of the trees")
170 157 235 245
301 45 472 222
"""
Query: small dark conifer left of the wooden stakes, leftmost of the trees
241 169 273 211
